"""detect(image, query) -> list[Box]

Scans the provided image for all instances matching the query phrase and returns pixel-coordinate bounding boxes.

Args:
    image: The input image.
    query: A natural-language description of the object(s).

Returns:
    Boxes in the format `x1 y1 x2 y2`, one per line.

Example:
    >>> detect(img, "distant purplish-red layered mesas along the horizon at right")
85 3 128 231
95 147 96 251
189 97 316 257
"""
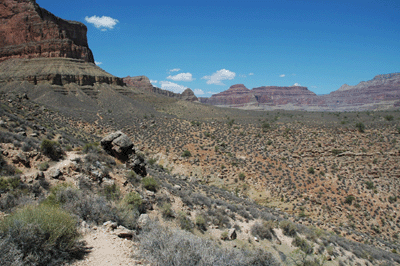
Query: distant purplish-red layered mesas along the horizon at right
200 73 400 111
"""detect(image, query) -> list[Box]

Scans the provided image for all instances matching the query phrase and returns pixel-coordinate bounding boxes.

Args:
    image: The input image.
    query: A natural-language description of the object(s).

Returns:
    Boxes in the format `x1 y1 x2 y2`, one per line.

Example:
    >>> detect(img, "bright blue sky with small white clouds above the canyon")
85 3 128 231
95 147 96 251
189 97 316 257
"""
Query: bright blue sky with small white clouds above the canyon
37 0 400 97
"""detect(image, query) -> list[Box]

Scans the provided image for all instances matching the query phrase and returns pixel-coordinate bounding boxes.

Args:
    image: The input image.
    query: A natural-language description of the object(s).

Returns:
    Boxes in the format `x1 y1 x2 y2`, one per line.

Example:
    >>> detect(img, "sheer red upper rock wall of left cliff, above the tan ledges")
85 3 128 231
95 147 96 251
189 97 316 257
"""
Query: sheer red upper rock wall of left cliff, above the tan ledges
0 0 94 63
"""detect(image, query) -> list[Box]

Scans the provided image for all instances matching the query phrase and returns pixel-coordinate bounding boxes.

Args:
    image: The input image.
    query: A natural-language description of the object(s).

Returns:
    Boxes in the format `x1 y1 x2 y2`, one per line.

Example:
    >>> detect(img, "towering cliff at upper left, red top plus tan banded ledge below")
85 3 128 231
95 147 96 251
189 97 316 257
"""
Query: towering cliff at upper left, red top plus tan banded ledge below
0 0 124 86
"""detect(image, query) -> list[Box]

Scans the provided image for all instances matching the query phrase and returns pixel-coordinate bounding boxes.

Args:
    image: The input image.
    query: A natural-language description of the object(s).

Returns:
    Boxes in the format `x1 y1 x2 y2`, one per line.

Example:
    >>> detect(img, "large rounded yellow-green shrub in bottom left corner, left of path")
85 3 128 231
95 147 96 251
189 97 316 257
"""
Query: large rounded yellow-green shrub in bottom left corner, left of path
0 205 80 265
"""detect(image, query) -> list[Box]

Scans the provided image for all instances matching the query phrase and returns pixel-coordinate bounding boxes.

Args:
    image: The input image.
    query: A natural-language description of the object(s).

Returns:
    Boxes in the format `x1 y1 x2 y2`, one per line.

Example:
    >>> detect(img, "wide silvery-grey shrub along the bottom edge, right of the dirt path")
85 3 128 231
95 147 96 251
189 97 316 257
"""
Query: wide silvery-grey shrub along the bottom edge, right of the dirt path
139 223 278 266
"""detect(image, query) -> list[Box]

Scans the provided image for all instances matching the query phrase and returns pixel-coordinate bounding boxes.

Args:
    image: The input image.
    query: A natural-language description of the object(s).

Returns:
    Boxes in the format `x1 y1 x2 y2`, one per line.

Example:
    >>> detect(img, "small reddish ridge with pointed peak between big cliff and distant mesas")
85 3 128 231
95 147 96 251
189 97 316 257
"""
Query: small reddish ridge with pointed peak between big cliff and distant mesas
123 76 198 102
